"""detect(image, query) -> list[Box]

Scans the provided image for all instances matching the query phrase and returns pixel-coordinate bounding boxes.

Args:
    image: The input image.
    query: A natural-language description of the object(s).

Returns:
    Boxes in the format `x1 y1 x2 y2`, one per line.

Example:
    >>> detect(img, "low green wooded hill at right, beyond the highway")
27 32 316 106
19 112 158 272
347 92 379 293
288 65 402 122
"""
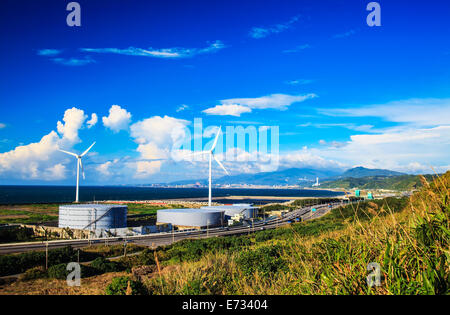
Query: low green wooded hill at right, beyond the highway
320 175 433 191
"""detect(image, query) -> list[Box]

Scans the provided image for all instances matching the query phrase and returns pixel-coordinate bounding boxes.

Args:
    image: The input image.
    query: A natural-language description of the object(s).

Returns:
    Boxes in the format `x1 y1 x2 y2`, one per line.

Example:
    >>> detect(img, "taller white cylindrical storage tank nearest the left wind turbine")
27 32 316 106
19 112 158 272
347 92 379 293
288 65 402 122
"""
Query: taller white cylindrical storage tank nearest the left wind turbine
58 204 128 230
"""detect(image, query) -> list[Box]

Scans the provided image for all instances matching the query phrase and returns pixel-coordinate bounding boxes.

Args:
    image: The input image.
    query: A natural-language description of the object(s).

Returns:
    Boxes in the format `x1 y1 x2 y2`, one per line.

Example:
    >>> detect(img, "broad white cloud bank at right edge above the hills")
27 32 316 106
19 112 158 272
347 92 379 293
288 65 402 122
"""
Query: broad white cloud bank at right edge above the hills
308 126 450 173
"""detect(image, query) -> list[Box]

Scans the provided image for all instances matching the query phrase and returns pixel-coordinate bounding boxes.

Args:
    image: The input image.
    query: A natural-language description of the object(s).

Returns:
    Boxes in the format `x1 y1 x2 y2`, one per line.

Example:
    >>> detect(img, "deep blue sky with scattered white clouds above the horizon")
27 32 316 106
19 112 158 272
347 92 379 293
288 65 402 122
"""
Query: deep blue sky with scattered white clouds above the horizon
0 0 450 184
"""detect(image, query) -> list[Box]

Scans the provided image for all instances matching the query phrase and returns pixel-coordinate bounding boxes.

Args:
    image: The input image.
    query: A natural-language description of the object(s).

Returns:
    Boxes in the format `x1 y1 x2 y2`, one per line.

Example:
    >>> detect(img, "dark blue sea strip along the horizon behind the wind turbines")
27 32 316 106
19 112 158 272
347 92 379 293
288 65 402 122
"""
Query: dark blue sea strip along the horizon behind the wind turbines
0 186 344 205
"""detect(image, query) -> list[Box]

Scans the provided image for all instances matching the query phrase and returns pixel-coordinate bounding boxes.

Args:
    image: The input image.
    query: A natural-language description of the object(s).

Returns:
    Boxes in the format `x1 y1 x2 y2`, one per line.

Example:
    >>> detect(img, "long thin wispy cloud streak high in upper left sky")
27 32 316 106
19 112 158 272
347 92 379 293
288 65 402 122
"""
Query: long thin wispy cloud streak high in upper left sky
80 40 226 59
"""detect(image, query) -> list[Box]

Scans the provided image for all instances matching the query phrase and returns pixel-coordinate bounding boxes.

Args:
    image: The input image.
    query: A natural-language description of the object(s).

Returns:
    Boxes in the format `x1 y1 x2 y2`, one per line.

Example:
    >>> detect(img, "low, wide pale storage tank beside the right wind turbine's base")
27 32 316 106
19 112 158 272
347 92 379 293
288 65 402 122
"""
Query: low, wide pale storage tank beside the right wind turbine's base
157 209 225 228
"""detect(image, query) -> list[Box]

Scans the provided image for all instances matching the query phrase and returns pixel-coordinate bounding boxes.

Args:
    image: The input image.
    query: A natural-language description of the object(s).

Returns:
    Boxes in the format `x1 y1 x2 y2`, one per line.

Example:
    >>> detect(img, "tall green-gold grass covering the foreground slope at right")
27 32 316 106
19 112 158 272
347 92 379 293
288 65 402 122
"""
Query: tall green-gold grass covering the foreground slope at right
144 172 450 295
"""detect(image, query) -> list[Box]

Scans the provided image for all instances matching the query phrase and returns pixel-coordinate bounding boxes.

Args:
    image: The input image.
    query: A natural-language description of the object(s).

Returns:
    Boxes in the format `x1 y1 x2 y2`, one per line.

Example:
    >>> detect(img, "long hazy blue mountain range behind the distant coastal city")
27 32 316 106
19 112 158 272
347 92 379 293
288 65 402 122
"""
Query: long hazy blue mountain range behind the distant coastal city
171 168 339 186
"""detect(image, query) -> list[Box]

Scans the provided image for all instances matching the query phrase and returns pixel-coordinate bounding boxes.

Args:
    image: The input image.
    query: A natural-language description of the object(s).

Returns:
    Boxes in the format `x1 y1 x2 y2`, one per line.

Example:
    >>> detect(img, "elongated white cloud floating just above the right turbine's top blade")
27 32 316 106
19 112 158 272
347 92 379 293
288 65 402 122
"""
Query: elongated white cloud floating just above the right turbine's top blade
203 93 317 117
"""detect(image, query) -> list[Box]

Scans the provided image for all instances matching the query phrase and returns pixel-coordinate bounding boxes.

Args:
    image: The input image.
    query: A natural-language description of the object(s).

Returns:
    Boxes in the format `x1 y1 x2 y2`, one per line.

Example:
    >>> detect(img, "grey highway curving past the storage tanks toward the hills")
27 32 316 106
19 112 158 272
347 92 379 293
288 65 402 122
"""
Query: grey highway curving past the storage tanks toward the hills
0 203 348 254
